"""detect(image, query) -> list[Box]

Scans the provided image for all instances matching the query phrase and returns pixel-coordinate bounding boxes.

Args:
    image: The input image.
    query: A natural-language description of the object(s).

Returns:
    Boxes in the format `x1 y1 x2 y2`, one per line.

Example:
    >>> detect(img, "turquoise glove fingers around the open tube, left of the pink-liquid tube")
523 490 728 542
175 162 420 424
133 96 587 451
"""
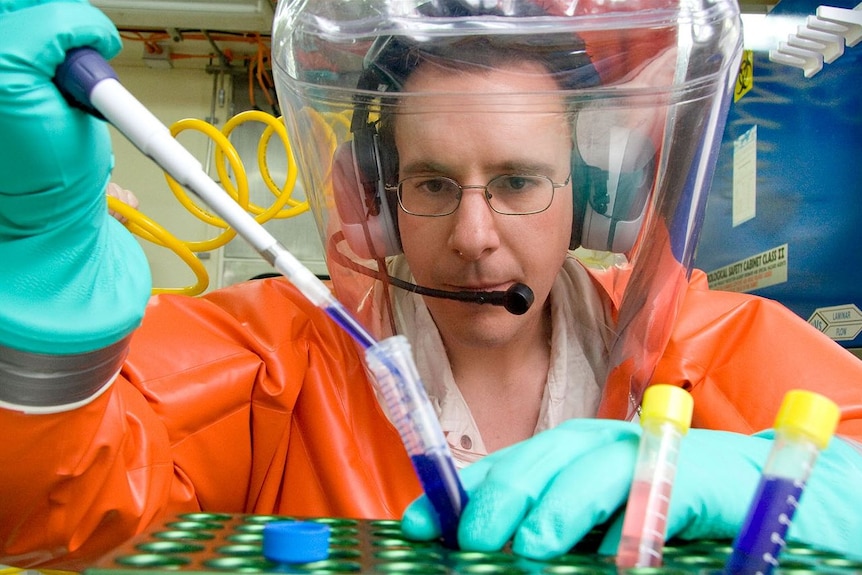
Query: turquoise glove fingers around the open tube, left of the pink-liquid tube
402 419 641 559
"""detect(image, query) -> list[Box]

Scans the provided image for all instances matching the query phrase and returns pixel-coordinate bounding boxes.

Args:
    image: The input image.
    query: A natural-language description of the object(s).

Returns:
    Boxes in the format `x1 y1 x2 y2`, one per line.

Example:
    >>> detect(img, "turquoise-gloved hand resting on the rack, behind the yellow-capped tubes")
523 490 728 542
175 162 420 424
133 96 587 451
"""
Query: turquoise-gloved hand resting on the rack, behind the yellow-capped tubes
402 419 862 559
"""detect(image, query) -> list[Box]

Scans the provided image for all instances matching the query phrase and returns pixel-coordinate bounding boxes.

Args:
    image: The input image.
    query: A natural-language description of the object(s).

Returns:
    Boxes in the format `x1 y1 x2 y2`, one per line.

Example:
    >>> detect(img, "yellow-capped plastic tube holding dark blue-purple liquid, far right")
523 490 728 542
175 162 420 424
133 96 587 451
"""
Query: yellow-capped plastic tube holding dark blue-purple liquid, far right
724 390 841 575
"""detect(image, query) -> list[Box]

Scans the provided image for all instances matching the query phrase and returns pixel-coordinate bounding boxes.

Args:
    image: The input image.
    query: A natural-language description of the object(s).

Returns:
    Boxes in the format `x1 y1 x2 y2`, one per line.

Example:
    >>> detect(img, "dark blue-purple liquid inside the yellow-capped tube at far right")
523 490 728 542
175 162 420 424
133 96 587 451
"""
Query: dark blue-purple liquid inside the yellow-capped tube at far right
725 476 803 575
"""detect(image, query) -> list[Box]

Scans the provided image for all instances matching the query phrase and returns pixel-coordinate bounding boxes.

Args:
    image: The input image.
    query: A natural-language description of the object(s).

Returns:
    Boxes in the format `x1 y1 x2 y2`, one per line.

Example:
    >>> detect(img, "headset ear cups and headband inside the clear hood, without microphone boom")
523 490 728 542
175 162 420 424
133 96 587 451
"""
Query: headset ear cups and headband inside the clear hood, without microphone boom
333 11 656 259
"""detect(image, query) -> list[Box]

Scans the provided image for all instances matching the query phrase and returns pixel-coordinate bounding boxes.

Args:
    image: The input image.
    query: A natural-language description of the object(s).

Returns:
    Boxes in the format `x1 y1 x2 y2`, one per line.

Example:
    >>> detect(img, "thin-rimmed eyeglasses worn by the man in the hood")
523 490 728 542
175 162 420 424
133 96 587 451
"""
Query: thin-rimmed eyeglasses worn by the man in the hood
386 173 572 217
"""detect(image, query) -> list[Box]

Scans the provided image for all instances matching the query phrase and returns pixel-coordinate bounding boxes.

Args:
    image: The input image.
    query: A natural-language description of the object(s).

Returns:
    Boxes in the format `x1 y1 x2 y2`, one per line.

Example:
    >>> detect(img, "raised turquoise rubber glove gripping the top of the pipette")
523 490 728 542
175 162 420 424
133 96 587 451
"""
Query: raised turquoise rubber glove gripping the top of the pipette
0 0 150 355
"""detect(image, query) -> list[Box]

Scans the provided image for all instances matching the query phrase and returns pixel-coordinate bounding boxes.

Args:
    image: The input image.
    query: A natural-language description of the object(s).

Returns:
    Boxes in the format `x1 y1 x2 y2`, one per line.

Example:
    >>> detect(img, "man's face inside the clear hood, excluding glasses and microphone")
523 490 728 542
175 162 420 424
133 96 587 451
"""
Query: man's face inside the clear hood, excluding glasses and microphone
394 63 572 347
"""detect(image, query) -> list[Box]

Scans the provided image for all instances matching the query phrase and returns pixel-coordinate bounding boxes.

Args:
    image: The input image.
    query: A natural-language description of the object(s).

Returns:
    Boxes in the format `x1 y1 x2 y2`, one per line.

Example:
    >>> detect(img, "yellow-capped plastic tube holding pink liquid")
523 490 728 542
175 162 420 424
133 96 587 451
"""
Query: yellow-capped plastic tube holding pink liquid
616 384 694 569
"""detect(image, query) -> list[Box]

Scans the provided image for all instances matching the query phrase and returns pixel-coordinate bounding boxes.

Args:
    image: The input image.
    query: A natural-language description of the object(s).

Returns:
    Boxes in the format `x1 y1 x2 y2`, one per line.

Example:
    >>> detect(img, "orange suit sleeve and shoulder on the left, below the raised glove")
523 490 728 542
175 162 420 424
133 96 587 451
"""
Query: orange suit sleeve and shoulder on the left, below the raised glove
0 279 419 569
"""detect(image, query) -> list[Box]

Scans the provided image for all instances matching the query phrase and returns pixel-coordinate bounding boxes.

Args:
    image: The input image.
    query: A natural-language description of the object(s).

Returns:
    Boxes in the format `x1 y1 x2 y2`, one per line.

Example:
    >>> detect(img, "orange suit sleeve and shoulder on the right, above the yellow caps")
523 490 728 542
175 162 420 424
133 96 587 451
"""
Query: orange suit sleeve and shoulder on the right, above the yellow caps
653 272 862 442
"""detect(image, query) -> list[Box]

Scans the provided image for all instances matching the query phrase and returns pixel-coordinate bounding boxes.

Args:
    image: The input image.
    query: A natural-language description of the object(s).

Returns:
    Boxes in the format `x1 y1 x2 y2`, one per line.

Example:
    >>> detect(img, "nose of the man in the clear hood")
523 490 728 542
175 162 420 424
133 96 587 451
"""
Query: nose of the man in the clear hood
449 186 499 260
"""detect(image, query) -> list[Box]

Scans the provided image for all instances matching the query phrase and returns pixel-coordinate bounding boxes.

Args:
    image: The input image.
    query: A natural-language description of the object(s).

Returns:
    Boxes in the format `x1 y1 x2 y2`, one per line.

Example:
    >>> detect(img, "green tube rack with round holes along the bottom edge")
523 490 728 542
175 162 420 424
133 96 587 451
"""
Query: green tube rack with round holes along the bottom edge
84 513 862 575
